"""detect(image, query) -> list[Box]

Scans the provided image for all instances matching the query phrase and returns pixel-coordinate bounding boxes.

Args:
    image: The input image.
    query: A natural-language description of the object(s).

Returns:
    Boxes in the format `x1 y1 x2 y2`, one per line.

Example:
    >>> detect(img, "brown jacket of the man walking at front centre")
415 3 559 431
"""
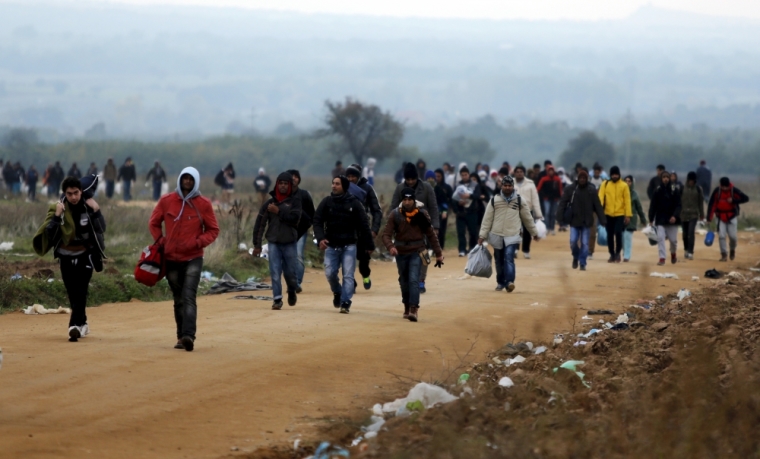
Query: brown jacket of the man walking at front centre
383 202 443 257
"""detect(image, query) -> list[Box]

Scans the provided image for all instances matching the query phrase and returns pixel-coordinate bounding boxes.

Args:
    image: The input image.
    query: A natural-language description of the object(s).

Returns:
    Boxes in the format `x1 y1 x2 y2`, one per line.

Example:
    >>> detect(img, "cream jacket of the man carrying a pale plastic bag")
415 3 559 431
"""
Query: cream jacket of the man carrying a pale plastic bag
479 193 538 239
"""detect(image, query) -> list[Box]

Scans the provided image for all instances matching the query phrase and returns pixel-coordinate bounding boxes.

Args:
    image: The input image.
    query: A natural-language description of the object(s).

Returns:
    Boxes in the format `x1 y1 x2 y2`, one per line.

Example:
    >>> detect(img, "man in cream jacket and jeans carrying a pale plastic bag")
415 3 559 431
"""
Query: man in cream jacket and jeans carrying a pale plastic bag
478 176 539 292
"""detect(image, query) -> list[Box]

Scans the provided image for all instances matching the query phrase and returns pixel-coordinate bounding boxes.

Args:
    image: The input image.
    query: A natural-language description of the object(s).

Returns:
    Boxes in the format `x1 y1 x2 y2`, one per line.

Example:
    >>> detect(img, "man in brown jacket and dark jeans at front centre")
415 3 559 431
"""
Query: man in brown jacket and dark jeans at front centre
382 189 443 322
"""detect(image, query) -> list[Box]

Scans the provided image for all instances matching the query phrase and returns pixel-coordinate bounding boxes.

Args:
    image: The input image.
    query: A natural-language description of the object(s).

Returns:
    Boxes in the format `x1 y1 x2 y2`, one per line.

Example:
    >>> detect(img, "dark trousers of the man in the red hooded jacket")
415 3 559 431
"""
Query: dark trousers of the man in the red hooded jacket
166 258 203 340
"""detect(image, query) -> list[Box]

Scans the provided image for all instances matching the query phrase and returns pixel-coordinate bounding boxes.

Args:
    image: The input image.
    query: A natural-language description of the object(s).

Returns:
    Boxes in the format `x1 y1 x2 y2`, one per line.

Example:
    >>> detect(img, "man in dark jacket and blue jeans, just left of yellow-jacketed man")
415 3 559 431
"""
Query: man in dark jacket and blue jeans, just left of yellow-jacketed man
557 169 607 271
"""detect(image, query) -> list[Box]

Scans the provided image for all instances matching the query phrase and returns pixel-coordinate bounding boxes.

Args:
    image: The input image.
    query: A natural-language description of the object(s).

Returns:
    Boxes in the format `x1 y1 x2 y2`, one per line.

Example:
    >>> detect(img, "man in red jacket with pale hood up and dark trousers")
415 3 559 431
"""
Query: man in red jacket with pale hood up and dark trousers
148 167 219 352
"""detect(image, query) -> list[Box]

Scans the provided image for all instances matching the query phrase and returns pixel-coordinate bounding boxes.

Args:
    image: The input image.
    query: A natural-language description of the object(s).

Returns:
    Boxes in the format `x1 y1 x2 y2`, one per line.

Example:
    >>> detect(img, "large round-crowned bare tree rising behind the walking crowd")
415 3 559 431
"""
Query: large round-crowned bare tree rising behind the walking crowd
315 98 404 164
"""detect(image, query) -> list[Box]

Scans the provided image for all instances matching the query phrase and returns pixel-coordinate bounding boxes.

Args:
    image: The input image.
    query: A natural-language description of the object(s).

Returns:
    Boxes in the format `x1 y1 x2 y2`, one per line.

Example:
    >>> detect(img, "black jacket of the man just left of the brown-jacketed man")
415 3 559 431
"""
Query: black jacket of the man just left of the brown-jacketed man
314 193 375 250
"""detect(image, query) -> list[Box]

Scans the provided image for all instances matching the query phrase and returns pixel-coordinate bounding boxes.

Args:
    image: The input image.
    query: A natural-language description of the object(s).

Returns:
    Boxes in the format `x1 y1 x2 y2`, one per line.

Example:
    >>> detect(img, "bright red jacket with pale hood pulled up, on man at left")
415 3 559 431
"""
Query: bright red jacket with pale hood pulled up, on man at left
148 167 219 262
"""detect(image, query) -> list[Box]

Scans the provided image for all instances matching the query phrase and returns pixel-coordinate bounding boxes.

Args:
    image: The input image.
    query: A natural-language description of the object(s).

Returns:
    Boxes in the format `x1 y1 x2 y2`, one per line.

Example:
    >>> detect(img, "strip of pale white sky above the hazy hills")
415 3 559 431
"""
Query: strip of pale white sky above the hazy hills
58 0 760 20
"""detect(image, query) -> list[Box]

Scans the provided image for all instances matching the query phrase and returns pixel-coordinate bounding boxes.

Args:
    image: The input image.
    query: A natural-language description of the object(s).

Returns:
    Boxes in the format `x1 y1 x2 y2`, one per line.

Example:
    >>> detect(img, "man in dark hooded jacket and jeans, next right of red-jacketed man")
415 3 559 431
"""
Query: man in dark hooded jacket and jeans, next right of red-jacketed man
253 172 301 310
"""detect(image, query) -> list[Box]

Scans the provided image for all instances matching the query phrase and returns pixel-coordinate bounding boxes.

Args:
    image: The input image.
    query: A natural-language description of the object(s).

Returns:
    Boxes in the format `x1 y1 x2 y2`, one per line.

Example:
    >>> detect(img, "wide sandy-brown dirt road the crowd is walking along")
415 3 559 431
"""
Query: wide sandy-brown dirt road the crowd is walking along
0 233 760 458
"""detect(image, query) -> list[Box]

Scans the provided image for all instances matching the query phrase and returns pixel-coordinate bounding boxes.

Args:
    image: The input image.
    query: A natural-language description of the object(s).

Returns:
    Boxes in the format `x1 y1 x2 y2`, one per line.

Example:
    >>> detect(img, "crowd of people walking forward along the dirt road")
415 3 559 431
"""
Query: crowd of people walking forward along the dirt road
33 161 748 351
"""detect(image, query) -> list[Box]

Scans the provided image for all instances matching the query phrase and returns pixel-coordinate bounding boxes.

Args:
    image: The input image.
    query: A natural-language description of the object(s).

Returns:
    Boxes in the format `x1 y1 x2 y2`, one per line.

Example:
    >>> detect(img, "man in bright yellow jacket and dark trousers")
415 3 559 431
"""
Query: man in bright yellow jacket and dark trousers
599 166 633 263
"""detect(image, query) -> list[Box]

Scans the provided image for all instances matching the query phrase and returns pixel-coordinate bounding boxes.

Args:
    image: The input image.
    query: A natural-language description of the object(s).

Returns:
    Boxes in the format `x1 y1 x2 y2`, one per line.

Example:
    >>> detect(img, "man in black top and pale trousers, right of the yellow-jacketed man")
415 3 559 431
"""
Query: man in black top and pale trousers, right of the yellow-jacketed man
649 171 681 266
